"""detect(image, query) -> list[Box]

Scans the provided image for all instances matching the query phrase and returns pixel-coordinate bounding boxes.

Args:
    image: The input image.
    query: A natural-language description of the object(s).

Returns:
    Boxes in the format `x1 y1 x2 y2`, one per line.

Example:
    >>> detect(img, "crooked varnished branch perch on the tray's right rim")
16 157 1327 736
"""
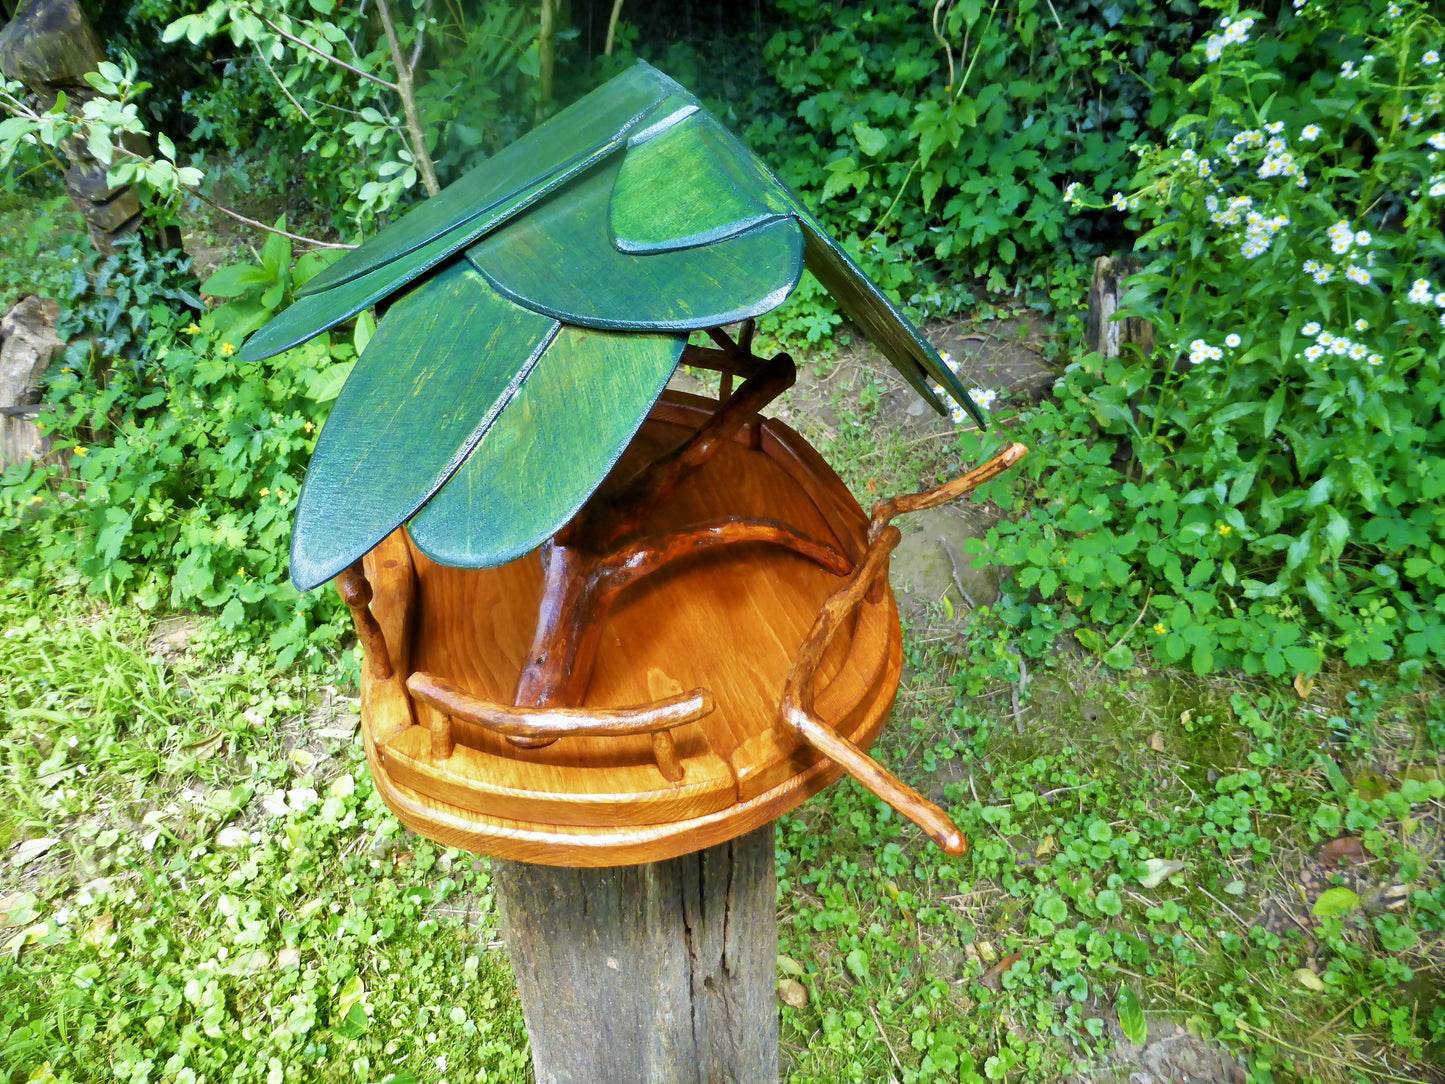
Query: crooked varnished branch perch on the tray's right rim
777 444 1029 854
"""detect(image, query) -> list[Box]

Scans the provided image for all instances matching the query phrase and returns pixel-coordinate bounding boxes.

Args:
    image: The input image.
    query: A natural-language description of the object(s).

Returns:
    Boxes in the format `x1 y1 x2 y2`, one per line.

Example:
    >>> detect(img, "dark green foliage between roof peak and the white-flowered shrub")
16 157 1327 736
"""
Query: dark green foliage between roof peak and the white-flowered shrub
744 0 1198 312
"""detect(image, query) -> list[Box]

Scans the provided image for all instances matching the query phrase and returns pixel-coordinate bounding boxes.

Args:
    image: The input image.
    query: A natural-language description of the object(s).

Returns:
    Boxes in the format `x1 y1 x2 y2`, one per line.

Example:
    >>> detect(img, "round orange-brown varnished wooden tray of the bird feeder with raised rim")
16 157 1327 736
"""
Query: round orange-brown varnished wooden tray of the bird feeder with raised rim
361 393 902 866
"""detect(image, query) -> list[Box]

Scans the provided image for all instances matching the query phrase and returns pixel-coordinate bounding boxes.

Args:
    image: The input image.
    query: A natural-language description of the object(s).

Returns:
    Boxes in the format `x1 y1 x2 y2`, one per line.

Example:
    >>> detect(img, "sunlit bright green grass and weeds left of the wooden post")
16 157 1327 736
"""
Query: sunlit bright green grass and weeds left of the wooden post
0 580 527 1084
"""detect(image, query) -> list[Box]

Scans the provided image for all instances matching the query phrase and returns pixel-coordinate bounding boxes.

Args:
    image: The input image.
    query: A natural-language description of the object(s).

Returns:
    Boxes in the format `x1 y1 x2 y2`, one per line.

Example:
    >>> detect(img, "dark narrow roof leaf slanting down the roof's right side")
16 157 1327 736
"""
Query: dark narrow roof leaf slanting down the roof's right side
799 211 987 428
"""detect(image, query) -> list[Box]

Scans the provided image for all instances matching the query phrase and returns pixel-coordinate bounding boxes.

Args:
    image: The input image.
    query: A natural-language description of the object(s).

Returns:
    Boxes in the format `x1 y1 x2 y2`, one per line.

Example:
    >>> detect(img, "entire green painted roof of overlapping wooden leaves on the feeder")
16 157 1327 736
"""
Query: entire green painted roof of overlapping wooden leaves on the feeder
241 64 984 590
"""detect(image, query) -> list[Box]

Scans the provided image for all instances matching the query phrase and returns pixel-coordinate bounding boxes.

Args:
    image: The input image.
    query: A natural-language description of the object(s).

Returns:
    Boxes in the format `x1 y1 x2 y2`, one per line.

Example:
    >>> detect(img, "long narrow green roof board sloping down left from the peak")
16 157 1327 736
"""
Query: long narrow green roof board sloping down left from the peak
302 64 685 302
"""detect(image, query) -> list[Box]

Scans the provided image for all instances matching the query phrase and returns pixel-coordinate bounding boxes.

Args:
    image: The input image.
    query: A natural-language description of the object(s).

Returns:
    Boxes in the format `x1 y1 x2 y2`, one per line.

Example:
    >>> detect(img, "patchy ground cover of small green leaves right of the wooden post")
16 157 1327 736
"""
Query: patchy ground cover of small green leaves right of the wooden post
779 635 1445 1084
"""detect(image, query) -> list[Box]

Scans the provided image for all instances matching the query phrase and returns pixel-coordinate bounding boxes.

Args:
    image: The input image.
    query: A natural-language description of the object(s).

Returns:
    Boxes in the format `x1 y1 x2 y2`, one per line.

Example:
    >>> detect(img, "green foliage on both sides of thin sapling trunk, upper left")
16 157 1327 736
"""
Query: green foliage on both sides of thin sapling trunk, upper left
163 0 538 228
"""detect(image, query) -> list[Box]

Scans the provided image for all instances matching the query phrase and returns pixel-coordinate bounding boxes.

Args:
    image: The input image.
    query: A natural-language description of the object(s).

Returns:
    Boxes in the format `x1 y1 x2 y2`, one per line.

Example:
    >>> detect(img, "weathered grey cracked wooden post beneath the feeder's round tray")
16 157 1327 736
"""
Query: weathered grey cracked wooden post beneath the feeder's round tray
493 824 777 1084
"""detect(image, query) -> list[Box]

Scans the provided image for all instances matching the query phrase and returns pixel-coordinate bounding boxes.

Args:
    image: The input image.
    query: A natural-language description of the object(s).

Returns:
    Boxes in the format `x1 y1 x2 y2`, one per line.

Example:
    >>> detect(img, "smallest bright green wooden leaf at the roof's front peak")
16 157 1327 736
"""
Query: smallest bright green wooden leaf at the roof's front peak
610 107 779 253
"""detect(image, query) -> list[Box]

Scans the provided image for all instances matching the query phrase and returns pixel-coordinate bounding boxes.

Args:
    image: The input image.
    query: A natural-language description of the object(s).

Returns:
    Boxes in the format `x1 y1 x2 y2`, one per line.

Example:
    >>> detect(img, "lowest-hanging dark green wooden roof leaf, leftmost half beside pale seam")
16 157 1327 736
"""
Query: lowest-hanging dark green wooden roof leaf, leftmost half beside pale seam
290 260 558 591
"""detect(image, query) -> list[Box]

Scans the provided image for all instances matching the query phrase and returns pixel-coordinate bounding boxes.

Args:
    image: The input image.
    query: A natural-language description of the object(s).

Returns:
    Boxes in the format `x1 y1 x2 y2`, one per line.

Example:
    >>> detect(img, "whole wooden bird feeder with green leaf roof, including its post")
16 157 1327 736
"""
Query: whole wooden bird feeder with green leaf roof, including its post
254 64 1025 1080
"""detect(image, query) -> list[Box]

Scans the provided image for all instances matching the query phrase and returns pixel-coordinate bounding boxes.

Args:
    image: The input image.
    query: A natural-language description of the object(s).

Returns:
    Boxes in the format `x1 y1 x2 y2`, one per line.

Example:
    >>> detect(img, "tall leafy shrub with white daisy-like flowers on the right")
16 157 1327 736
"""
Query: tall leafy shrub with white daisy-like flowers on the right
971 0 1445 675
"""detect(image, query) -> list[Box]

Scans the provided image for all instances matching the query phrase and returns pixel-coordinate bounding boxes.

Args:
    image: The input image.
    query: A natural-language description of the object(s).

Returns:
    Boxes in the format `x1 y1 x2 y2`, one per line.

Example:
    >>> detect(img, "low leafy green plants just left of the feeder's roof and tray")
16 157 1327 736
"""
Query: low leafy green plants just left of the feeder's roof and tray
0 234 355 665
